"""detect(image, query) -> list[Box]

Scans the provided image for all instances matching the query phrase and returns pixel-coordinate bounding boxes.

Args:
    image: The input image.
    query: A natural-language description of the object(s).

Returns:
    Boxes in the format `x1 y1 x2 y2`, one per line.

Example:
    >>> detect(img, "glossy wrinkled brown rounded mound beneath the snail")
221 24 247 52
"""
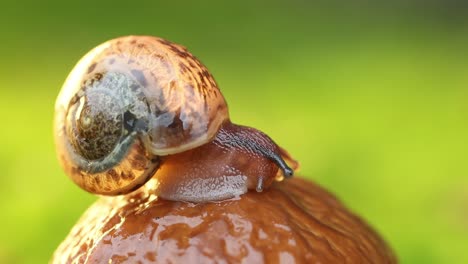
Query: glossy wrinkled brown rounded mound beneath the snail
52 178 397 263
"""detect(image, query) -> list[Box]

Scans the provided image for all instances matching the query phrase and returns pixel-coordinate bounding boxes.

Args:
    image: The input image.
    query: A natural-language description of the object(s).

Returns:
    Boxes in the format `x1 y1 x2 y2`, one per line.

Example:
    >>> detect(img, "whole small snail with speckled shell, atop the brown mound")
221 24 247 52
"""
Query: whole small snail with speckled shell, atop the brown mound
54 36 297 202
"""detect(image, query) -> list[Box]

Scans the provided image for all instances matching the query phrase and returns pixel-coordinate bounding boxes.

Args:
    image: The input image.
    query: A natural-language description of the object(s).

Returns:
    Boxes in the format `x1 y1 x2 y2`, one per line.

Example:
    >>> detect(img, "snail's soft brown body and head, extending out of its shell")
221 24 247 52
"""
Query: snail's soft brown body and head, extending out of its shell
155 122 299 202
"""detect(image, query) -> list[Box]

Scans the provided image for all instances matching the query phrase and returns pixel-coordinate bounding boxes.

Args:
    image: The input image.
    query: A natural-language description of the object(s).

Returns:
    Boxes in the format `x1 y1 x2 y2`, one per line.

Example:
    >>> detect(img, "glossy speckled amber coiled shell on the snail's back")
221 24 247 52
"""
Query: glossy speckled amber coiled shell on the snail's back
54 36 229 195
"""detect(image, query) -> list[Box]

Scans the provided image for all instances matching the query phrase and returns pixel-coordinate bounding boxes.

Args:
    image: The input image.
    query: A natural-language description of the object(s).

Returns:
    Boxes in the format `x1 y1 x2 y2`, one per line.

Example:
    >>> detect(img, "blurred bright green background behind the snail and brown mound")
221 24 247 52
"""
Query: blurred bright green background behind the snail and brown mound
0 0 468 263
